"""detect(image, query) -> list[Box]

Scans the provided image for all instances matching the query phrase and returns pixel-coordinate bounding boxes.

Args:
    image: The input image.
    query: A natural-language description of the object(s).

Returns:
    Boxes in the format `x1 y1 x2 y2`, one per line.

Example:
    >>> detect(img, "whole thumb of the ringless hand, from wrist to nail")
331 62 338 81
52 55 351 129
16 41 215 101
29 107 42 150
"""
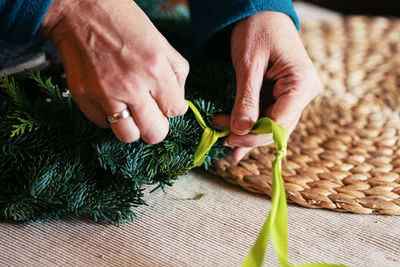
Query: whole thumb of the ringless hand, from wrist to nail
231 12 270 135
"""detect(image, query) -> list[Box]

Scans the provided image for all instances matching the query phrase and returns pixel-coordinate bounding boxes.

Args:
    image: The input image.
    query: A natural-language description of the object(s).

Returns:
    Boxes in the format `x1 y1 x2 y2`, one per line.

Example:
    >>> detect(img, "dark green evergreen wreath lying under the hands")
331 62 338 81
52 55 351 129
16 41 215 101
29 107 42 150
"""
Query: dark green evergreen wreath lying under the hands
0 1 239 225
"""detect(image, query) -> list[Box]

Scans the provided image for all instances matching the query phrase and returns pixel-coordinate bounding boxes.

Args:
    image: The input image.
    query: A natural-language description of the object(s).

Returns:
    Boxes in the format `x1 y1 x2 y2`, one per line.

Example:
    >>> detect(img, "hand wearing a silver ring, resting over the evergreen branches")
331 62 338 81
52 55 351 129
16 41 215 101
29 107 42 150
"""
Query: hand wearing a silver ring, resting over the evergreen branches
40 0 189 144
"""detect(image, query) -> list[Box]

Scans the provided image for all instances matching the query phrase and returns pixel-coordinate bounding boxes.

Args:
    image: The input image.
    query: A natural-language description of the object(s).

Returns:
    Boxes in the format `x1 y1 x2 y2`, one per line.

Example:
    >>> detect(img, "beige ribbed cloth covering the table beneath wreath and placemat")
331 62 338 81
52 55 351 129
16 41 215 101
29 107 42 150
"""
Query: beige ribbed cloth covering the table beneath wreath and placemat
0 3 400 266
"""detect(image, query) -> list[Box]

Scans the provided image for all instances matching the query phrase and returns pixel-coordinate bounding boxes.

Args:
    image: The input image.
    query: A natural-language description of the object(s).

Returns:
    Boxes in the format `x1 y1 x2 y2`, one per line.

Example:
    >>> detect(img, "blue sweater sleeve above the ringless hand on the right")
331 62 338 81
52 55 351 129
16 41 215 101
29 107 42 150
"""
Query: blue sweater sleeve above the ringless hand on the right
189 0 299 50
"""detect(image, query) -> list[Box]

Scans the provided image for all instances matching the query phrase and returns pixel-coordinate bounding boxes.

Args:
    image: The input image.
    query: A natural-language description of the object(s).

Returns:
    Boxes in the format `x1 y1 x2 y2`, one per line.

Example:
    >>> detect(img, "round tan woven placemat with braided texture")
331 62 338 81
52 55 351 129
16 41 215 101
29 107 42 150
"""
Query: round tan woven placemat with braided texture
210 16 400 215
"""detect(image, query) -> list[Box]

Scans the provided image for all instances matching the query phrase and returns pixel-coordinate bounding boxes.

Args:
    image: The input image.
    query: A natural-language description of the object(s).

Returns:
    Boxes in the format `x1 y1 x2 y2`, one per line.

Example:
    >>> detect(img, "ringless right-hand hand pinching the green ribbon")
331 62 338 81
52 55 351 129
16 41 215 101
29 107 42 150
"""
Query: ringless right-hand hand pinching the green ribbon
214 11 320 161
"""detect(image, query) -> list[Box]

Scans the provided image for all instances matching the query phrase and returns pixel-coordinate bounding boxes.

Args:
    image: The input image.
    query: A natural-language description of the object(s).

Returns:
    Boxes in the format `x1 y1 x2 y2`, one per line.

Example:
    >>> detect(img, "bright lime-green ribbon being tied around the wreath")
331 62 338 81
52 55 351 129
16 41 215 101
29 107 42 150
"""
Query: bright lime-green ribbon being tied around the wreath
187 101 344 267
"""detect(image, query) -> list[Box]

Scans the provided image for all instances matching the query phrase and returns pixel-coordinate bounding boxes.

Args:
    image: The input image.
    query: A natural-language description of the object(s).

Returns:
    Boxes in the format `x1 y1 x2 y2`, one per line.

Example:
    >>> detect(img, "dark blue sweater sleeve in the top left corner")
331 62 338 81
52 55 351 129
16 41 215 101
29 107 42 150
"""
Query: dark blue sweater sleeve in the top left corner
0 0 51 43
